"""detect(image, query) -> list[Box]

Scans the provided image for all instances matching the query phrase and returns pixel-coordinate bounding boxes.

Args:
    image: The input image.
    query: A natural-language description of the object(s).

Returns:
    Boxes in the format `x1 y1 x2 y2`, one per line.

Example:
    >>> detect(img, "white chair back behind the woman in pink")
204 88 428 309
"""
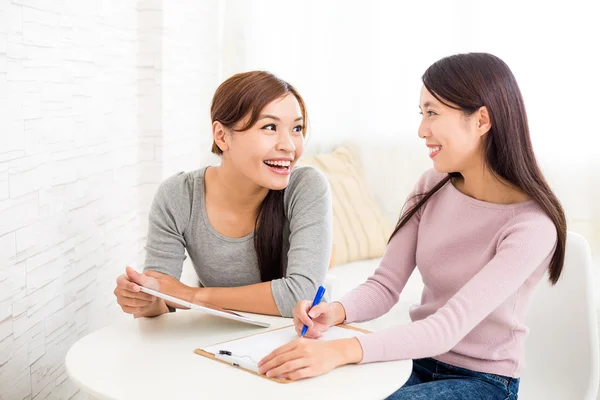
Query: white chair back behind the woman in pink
519 232 599 400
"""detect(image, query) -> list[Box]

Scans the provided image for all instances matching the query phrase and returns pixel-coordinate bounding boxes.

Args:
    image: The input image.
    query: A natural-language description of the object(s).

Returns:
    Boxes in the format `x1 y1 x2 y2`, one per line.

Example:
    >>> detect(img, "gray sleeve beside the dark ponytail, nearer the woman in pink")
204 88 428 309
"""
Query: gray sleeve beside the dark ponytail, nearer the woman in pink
271 167 333 317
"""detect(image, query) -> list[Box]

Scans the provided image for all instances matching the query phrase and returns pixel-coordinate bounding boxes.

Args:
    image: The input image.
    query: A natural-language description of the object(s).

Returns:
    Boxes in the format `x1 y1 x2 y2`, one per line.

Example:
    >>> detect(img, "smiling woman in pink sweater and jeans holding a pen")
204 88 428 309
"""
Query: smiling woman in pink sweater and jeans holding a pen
259 53 566 400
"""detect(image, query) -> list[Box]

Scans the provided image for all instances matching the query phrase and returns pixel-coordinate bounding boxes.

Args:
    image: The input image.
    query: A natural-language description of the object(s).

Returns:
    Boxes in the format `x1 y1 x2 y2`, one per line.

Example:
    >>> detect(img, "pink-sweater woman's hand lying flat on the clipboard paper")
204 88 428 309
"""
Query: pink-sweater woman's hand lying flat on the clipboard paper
258 338 362 381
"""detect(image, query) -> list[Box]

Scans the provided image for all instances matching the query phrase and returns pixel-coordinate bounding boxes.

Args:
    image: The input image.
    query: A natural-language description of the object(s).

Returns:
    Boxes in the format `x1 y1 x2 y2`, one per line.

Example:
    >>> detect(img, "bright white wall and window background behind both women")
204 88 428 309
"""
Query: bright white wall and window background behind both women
0 0 600 399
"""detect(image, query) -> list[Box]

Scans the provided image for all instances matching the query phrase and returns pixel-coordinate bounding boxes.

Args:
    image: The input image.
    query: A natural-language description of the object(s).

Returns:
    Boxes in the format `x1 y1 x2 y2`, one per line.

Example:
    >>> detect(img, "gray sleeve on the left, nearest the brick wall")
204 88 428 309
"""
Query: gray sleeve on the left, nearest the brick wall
144 173 192 279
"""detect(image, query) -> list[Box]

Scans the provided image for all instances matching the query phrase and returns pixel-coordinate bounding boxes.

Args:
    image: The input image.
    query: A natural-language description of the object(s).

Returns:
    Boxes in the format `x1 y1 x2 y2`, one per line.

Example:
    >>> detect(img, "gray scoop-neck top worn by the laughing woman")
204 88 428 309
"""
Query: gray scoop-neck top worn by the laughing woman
144 167 333 317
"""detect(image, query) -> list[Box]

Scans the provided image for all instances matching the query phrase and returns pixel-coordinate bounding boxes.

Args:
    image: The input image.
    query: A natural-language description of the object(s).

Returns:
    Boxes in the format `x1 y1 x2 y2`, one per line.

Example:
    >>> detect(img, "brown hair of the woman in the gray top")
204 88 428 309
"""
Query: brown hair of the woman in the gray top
210 71 308 282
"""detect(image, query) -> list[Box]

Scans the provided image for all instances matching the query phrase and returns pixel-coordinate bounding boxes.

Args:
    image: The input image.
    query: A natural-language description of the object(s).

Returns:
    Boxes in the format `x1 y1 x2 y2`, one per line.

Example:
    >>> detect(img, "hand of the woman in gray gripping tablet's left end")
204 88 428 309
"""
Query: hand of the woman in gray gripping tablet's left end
114 267 169 317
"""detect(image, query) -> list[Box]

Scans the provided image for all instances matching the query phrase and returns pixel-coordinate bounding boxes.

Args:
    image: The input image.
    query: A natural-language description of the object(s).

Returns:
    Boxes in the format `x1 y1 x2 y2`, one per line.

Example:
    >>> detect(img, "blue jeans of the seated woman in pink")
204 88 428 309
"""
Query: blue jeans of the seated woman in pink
388 358 519 400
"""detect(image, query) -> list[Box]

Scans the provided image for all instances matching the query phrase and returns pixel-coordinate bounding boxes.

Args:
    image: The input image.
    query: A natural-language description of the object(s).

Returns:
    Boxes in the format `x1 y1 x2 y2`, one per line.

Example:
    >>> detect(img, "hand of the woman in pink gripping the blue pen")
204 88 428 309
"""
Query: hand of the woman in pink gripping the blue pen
293 300 346 338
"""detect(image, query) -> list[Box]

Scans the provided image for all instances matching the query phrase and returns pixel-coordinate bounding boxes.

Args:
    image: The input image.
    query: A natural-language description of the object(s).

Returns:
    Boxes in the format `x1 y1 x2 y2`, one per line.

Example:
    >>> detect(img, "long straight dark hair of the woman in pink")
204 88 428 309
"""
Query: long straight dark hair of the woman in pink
390 53 567 284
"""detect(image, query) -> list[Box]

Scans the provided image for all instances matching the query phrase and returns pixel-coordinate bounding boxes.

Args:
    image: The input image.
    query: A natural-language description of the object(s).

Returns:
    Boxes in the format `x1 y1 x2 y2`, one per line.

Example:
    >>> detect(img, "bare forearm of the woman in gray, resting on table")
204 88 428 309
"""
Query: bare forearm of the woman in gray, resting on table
194 282 281 315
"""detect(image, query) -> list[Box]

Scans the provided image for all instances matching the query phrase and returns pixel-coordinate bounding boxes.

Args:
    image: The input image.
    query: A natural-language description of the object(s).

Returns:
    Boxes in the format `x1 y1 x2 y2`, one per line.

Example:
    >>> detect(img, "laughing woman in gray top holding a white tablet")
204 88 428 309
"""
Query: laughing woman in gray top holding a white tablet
114 71 332 317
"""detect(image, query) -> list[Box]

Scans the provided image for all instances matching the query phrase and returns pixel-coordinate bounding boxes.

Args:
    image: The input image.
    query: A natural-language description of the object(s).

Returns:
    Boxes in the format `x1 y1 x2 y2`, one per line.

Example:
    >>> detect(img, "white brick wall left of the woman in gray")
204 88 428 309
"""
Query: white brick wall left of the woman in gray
0 0 220 400
